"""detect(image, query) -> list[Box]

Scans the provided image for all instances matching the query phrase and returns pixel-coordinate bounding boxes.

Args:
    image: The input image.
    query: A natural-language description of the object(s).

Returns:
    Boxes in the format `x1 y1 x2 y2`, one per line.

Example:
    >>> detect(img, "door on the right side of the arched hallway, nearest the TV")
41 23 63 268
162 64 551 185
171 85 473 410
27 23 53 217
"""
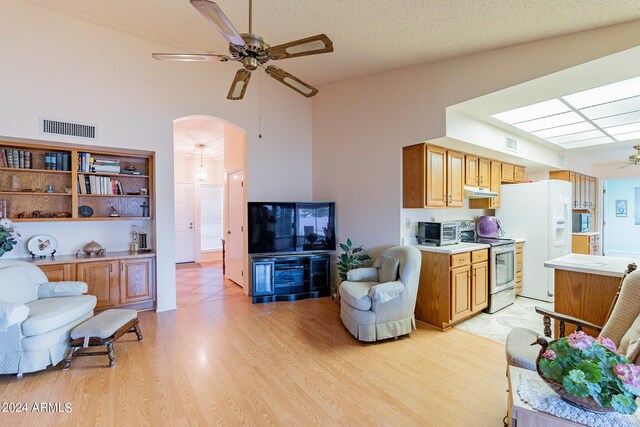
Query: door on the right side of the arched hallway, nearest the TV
225 170 244 286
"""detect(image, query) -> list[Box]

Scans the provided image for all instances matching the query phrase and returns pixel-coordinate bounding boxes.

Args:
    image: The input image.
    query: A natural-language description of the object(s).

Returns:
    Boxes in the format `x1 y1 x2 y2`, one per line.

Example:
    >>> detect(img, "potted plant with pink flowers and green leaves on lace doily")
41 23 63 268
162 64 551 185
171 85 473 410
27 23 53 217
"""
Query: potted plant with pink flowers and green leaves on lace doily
536 331 640 415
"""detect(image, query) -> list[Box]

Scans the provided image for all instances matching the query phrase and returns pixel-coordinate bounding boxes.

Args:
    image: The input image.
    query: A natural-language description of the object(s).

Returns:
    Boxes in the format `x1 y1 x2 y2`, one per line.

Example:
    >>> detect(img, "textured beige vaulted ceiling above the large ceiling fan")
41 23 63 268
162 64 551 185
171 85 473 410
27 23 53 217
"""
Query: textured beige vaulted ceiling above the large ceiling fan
25 0 640 85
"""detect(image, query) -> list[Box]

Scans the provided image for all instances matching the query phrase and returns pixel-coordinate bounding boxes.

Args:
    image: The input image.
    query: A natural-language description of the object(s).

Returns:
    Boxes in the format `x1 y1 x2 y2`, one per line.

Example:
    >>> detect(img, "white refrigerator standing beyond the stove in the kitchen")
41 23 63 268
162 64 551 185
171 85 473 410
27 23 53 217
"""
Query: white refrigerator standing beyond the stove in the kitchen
496 180 572 302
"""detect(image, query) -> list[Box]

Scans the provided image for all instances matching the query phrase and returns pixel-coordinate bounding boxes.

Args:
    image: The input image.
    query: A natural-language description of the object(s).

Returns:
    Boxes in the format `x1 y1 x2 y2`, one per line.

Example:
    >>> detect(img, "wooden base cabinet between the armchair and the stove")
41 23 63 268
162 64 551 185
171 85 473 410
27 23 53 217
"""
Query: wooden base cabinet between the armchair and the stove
416 249 489 330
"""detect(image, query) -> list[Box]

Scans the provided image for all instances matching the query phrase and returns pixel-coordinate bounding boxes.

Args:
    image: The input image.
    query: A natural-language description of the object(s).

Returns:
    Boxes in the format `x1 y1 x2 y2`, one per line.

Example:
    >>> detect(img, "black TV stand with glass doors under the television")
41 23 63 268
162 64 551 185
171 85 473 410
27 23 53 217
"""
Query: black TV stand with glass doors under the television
250 252 331 304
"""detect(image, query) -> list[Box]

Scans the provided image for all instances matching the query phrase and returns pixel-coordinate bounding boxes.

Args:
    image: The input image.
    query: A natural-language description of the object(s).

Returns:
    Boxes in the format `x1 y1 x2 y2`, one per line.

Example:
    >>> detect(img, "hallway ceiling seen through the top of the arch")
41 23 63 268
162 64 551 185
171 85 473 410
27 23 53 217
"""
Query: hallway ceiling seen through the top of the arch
173 117 224 162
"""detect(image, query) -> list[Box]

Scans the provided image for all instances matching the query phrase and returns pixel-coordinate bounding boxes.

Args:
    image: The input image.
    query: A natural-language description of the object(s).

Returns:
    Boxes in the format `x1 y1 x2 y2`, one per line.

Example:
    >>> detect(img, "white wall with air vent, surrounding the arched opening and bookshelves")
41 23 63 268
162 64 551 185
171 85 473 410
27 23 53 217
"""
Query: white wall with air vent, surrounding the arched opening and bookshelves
0 0 312 311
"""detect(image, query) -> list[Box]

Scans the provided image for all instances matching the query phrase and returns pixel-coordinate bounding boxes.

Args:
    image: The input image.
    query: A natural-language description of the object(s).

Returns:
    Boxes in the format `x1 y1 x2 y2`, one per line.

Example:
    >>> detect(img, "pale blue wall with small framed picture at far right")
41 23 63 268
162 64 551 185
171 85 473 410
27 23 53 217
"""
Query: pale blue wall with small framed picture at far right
602 178 640 259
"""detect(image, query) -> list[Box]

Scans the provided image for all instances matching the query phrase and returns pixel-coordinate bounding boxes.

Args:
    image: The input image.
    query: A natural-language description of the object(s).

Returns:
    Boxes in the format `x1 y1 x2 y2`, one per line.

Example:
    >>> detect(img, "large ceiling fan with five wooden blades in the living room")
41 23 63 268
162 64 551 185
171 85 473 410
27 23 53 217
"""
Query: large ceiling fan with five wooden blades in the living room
151 0 333 100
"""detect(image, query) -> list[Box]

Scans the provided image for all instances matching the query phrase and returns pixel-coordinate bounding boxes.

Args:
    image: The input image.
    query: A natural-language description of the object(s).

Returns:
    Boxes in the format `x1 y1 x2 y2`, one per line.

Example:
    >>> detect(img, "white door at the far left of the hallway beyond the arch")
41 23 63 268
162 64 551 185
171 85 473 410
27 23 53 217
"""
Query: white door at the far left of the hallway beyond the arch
176 184 196 263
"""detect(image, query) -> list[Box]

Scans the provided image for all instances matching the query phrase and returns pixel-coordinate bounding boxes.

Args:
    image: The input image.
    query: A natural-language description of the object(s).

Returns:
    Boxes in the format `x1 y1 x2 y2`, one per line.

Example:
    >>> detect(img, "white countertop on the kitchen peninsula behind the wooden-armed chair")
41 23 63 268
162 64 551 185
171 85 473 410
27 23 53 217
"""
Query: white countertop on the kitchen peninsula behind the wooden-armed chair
544 254 640 277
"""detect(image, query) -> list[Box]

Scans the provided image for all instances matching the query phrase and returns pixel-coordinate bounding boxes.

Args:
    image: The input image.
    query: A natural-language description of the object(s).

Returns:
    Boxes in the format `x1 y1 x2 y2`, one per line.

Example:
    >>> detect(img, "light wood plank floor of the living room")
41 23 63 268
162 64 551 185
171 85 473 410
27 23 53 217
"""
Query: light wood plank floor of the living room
0 269 507 426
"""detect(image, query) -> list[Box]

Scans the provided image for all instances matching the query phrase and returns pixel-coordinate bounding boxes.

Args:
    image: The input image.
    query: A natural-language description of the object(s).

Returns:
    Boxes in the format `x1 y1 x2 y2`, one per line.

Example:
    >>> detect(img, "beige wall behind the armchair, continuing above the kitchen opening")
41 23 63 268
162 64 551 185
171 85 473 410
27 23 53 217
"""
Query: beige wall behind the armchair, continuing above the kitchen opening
313 22 640 255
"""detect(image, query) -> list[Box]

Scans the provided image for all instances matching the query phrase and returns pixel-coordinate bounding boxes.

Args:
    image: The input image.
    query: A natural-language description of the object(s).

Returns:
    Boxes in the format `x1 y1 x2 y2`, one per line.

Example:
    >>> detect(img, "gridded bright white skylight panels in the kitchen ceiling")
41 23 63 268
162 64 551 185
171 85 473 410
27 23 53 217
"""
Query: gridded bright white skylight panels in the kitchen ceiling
492 77 640 149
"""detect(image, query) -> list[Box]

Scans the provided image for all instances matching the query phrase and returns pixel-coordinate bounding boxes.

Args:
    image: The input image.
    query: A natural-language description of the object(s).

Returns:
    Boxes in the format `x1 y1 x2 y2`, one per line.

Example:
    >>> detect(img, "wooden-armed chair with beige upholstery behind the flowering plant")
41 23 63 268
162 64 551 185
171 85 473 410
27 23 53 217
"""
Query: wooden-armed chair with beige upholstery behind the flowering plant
505 266 640 371
